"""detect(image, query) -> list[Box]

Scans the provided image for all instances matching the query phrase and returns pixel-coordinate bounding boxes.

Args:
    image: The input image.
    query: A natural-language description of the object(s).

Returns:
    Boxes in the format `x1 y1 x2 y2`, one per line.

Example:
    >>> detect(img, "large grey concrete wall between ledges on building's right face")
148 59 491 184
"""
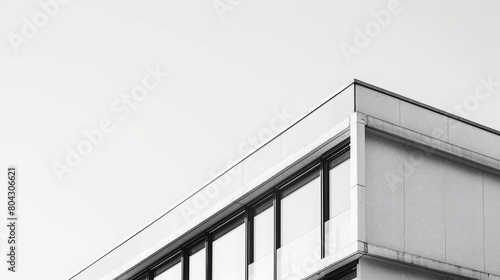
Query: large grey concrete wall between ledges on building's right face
366 134 500 274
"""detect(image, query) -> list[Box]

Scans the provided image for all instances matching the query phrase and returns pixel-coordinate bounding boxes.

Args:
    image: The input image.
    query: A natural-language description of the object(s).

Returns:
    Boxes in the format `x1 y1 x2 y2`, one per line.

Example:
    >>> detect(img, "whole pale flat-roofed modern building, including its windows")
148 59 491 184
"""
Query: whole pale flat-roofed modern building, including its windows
72 80 500 280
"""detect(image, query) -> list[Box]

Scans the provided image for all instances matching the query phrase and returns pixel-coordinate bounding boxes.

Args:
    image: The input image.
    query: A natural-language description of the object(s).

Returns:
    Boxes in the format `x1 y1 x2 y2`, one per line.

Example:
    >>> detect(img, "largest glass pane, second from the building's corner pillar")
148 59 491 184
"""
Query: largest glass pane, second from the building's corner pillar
278 174 321 279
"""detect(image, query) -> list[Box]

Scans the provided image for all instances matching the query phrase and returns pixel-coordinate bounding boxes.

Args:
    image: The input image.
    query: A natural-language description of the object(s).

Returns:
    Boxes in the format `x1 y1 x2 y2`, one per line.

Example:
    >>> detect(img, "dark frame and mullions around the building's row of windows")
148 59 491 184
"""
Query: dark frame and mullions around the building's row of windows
130 138 350 280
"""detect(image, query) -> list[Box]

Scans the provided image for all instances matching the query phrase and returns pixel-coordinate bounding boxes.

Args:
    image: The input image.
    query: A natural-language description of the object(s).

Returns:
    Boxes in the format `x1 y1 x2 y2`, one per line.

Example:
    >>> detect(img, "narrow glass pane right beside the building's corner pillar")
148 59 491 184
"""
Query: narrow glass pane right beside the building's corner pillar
325 159 351 255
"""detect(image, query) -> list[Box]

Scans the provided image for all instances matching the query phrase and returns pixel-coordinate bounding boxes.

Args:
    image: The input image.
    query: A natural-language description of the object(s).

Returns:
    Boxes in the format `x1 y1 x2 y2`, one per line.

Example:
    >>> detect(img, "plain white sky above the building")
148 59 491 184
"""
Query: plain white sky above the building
0 0 500 280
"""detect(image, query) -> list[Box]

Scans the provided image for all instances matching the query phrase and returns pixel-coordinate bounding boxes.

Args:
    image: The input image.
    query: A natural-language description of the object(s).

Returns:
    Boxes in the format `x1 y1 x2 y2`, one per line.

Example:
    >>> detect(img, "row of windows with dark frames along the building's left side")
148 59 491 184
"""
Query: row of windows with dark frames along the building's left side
134 143 355 280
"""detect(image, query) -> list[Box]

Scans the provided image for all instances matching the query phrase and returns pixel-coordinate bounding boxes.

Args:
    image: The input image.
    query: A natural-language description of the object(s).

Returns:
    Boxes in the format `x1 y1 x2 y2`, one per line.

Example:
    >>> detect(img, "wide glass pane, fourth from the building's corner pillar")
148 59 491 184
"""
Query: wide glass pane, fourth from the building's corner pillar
212 224 245 280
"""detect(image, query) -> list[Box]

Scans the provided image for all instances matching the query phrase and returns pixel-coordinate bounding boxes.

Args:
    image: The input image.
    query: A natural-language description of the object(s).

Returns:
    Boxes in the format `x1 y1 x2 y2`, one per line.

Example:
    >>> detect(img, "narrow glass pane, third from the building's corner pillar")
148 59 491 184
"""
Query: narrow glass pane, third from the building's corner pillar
248 206 274 280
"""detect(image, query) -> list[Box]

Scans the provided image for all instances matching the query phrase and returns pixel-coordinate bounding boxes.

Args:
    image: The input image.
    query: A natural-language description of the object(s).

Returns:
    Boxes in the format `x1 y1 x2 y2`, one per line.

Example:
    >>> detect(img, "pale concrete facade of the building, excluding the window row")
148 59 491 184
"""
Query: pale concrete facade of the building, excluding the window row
72 80 500 280
